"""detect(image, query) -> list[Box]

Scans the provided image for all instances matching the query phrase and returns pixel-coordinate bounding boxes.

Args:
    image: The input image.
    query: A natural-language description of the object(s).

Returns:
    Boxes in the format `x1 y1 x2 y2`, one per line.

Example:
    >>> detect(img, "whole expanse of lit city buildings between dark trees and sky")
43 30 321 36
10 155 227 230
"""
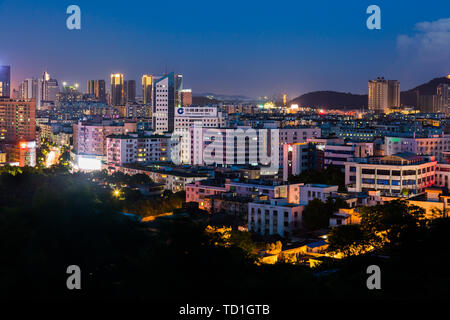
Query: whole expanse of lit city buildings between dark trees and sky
0 67 450 246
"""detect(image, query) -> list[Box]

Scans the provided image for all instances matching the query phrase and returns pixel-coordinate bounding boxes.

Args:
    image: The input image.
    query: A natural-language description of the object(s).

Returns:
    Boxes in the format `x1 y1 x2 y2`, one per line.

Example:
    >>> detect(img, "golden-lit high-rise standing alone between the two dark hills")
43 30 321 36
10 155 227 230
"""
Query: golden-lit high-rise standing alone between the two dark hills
368 77 400 113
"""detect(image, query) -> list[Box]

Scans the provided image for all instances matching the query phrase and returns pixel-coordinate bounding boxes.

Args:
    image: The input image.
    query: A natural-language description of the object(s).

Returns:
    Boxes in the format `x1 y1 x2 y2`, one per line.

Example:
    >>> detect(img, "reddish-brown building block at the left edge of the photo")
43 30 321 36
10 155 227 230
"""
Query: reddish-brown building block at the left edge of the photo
0 98 36 142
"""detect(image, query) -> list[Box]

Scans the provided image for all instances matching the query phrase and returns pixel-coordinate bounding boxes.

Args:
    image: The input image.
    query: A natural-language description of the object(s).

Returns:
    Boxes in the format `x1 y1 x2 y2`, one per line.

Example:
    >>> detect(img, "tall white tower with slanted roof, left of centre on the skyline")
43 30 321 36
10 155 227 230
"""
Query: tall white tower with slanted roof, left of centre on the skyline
152 72 183 133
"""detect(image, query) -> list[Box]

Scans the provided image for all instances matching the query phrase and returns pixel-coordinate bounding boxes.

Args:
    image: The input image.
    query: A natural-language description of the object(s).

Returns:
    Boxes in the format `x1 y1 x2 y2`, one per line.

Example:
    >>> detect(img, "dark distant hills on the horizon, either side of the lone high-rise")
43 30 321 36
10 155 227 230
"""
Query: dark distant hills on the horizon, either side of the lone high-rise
291 77 450 109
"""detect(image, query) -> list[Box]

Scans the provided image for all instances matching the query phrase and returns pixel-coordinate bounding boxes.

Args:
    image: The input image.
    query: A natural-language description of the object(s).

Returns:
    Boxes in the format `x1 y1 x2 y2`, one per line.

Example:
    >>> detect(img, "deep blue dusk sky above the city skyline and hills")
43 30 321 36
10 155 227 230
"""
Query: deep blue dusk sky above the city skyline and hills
0 0 450 97
